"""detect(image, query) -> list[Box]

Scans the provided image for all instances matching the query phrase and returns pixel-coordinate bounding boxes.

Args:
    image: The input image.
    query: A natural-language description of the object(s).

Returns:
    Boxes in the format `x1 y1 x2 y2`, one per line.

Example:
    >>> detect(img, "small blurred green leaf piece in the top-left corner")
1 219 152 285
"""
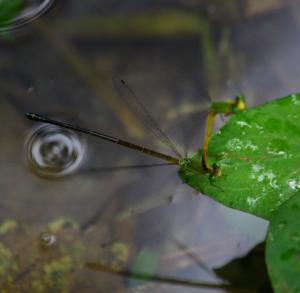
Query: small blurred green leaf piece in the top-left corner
0 0 24 28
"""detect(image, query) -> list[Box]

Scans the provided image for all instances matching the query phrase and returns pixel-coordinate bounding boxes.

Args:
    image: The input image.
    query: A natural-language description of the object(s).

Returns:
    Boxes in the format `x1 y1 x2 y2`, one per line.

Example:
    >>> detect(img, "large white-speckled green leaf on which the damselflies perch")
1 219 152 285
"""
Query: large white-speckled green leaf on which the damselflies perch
179 94 300 219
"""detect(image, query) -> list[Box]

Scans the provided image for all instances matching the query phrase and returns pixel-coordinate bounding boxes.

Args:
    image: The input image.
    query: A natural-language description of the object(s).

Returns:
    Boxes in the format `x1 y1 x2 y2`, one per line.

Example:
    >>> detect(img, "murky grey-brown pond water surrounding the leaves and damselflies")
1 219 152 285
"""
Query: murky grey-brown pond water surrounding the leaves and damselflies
0 0 300 292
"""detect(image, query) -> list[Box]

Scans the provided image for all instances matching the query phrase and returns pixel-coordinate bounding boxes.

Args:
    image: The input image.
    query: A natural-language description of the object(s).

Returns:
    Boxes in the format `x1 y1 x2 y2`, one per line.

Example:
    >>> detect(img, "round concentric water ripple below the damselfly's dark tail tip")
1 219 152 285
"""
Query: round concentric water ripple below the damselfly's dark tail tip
26 125 86 178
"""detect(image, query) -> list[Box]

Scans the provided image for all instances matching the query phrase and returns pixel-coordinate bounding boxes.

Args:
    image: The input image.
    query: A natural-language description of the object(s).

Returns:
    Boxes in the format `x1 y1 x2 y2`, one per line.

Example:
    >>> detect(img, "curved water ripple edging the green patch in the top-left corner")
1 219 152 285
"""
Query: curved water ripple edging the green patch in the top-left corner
0 0 54 32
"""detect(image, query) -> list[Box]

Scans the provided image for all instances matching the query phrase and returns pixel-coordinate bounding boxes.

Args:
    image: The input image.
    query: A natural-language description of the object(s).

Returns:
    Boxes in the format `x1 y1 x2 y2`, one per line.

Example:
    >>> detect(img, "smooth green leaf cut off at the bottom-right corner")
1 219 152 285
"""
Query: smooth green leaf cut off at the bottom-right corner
266 191 300 293
